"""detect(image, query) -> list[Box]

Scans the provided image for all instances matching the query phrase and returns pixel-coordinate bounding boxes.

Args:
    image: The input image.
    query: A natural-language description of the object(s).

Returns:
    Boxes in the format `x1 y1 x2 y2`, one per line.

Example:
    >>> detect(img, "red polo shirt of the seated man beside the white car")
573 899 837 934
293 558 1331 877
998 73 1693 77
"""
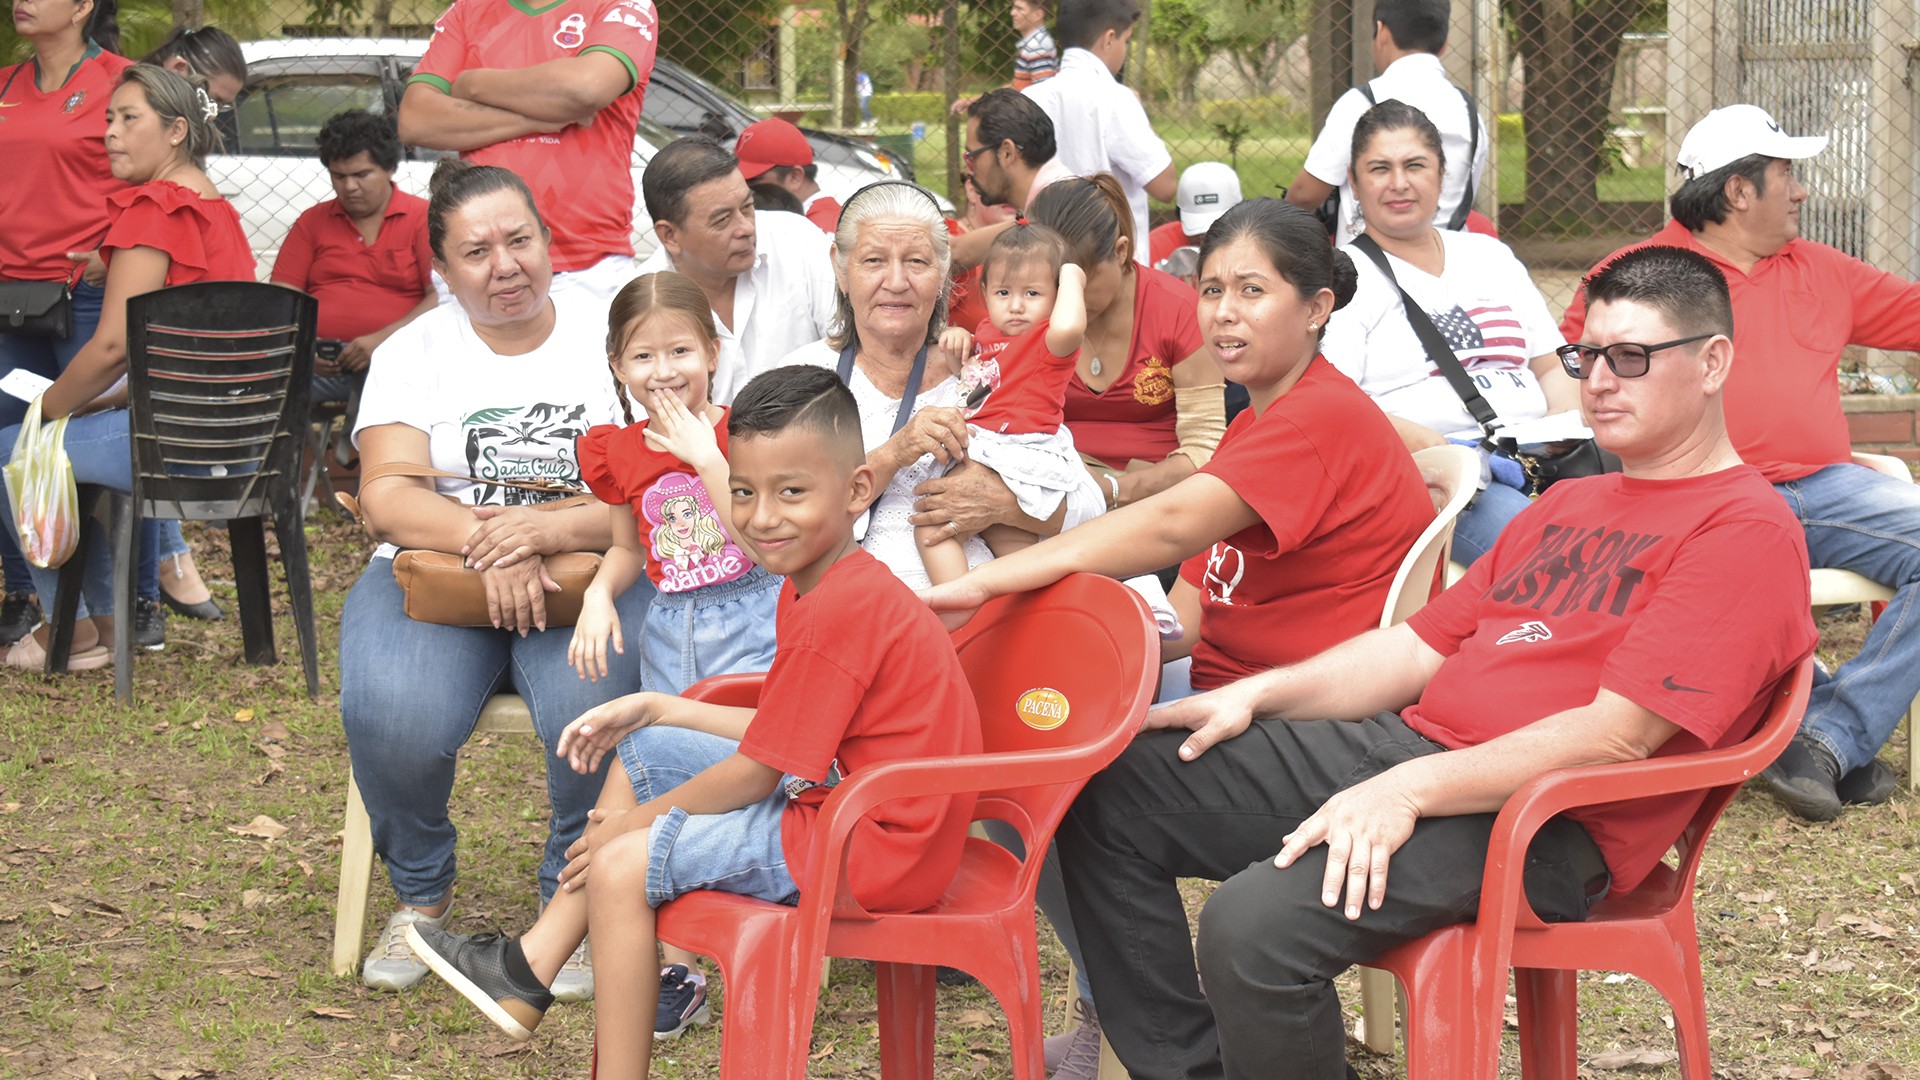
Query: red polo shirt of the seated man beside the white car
273 188 434 342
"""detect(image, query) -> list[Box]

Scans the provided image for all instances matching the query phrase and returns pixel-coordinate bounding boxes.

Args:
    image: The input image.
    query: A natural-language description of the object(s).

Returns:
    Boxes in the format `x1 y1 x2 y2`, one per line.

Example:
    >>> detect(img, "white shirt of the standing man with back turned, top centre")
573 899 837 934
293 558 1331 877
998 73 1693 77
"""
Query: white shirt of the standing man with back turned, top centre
1021 48 1175 263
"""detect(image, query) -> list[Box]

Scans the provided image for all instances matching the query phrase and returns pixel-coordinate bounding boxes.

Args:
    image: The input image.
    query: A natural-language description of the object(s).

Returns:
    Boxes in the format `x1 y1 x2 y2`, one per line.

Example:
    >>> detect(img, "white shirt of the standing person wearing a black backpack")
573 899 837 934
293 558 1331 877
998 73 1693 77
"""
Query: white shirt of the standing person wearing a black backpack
1306 52 1488 244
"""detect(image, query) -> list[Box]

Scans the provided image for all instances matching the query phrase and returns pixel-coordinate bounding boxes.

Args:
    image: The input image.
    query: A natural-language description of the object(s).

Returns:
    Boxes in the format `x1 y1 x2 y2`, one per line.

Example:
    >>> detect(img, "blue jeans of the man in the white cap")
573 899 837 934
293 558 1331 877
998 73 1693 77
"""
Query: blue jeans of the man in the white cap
1774 463 1920 773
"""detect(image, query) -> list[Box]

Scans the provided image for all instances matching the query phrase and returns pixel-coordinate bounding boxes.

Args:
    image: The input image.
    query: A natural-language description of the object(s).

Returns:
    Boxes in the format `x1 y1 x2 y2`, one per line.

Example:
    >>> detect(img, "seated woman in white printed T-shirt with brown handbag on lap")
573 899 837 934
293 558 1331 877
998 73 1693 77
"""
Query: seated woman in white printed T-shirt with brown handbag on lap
340 167 653 999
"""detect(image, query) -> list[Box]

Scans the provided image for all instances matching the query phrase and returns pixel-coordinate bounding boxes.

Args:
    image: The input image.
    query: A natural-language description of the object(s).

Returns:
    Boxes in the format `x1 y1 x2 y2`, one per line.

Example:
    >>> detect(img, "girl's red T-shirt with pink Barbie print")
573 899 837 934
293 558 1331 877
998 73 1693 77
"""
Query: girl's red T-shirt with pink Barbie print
574 407 753 592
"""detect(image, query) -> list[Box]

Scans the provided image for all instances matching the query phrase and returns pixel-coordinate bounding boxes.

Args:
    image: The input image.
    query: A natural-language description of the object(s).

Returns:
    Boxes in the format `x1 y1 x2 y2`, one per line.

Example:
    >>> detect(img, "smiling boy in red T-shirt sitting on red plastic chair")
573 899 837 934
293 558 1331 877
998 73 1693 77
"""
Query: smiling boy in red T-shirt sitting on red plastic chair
409 365 981 1076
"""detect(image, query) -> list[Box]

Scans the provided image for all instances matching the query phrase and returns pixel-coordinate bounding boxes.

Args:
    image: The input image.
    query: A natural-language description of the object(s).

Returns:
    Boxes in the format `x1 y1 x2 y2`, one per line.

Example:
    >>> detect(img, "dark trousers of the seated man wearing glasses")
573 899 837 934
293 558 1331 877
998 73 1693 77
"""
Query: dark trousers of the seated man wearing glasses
1056 713 1607 1080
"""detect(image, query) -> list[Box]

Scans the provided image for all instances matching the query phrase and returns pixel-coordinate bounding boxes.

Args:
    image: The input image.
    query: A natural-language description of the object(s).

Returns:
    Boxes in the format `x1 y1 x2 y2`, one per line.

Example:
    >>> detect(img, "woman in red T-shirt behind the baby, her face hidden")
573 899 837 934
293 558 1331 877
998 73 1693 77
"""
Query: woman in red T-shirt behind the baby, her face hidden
1027 173 1227 507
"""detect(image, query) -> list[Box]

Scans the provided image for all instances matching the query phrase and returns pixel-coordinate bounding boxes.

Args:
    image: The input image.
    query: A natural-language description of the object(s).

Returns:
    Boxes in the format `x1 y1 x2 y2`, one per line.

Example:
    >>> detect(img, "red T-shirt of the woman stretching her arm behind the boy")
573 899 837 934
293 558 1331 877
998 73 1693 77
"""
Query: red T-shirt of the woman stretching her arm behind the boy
1175 356 1434 690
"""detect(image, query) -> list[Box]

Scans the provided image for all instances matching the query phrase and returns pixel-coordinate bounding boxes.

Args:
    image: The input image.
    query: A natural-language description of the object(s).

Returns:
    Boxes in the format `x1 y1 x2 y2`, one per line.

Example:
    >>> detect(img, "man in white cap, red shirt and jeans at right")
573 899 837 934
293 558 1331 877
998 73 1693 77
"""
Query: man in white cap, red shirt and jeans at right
1561 106 1920 821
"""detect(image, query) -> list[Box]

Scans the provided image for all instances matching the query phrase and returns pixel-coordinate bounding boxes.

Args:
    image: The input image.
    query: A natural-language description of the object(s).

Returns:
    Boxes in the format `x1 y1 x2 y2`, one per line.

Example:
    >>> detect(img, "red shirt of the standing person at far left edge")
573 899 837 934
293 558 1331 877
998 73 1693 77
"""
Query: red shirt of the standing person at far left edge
0 42 132 281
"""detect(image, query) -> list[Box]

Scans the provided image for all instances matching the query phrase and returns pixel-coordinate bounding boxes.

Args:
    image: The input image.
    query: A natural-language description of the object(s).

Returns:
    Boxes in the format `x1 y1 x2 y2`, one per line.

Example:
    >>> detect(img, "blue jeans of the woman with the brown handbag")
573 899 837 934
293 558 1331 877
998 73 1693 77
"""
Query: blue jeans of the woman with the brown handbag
340 557 653 907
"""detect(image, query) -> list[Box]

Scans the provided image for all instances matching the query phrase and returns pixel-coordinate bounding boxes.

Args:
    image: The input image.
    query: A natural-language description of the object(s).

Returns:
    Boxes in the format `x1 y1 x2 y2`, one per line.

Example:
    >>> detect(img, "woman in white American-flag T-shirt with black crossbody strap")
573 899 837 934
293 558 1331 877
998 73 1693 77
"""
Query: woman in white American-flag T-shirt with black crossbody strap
1321 100 1580 565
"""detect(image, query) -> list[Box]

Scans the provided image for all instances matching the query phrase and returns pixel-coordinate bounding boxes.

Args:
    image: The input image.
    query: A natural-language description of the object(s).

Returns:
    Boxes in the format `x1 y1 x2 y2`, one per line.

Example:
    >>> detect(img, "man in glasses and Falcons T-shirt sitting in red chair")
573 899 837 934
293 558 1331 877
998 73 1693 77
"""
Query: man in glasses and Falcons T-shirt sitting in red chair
1058 248 1816 1080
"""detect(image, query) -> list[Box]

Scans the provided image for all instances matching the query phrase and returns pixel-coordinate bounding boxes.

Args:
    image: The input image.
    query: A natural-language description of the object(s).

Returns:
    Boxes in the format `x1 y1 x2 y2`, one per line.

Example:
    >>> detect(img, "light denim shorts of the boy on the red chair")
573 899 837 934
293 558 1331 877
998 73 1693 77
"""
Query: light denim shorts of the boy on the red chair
618 726 801 907
